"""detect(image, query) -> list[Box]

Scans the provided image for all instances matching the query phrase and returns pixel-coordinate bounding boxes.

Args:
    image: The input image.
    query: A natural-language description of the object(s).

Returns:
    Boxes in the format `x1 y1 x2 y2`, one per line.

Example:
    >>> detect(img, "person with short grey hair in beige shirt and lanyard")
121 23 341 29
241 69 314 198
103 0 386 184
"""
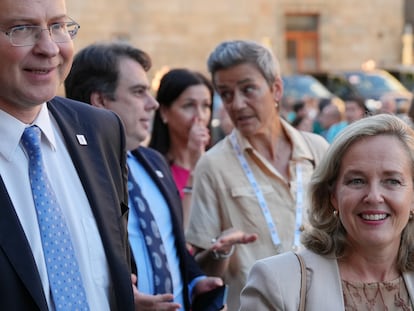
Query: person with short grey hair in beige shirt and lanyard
186 40 328 310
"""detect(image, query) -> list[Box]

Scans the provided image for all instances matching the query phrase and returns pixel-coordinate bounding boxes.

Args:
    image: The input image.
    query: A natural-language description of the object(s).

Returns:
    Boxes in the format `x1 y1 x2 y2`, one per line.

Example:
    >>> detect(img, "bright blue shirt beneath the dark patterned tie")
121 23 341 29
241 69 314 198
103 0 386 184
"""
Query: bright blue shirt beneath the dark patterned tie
128 152 184 306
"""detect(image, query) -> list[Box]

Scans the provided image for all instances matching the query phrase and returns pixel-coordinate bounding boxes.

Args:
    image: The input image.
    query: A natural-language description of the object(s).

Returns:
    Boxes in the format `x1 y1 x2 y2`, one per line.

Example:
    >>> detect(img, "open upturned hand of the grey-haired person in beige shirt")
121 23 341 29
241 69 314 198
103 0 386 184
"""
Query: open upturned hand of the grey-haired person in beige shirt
209 228 258 254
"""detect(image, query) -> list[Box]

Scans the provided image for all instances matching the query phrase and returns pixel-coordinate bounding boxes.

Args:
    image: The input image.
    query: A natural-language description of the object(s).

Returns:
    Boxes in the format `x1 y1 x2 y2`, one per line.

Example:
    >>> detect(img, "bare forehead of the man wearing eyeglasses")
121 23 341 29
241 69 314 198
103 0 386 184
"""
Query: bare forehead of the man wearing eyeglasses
0 0 66 23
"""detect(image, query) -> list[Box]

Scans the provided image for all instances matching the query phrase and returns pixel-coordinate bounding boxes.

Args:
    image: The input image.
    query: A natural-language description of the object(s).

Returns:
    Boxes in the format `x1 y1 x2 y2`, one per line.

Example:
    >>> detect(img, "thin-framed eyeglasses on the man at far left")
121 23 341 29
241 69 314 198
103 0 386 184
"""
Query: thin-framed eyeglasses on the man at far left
0 21 80 46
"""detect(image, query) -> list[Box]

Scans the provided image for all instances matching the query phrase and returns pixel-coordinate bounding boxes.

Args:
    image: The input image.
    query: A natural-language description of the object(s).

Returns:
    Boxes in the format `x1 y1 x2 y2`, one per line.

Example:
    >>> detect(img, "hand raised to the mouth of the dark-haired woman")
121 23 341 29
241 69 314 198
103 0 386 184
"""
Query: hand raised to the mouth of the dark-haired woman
187 117 210 168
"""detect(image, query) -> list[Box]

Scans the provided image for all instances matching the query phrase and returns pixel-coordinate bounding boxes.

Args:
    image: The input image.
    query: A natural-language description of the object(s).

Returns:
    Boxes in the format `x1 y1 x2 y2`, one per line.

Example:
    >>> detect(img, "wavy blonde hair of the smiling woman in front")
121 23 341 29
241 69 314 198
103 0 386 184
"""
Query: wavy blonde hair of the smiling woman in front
301 114 414 272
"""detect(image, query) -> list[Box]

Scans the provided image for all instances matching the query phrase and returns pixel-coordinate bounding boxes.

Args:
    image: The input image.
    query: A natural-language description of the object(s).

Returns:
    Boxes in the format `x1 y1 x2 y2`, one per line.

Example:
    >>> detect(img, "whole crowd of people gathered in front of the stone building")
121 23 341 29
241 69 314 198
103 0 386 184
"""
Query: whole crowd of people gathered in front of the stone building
4 0 414 311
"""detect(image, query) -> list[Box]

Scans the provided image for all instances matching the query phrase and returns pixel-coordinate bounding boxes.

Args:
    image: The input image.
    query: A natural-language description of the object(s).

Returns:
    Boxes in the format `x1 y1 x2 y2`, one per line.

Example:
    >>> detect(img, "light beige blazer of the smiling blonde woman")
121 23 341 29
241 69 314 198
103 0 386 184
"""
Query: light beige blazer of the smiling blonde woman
240 250 414 311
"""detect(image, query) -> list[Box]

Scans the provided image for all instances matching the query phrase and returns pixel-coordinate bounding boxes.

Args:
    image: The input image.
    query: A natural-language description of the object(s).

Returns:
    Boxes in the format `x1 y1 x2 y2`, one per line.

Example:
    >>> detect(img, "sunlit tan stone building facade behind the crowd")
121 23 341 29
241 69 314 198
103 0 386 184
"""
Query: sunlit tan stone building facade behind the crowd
67 0 404 83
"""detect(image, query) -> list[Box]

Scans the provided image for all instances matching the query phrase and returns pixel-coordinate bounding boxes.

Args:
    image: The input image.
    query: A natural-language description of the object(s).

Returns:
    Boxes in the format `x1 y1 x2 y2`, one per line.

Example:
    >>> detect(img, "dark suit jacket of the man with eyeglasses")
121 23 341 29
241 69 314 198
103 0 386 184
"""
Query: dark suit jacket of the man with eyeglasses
0 97 134 311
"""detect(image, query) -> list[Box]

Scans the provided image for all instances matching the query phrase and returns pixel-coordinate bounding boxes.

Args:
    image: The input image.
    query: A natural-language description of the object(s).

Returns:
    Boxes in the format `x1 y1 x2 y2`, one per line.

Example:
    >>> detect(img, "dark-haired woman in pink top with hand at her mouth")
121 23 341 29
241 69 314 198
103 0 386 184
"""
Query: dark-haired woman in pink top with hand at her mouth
149 69 214 232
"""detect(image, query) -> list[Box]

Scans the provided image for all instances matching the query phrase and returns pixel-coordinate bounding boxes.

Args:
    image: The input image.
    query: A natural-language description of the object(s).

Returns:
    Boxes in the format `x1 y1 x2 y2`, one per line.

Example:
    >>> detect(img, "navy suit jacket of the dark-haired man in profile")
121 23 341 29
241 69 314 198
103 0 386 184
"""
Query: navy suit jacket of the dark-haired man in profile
132 147 203 310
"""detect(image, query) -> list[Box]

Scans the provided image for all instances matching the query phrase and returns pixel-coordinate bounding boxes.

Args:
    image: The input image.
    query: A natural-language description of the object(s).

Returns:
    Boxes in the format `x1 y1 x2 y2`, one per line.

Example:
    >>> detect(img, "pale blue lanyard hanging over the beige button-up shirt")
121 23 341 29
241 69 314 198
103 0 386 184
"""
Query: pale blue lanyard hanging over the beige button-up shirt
230 131 304 250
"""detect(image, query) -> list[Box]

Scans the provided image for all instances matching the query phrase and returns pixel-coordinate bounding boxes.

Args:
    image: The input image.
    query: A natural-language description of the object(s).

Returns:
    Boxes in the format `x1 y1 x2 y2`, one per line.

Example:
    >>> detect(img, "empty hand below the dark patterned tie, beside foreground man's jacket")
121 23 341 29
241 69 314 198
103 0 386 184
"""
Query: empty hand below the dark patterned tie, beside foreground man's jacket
131 274 181 311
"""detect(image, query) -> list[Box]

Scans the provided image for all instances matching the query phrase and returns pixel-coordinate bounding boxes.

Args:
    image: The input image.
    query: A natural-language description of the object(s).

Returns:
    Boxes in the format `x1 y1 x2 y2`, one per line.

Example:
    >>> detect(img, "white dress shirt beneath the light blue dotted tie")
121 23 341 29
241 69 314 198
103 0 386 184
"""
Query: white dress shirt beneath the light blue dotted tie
0 104 111 310
